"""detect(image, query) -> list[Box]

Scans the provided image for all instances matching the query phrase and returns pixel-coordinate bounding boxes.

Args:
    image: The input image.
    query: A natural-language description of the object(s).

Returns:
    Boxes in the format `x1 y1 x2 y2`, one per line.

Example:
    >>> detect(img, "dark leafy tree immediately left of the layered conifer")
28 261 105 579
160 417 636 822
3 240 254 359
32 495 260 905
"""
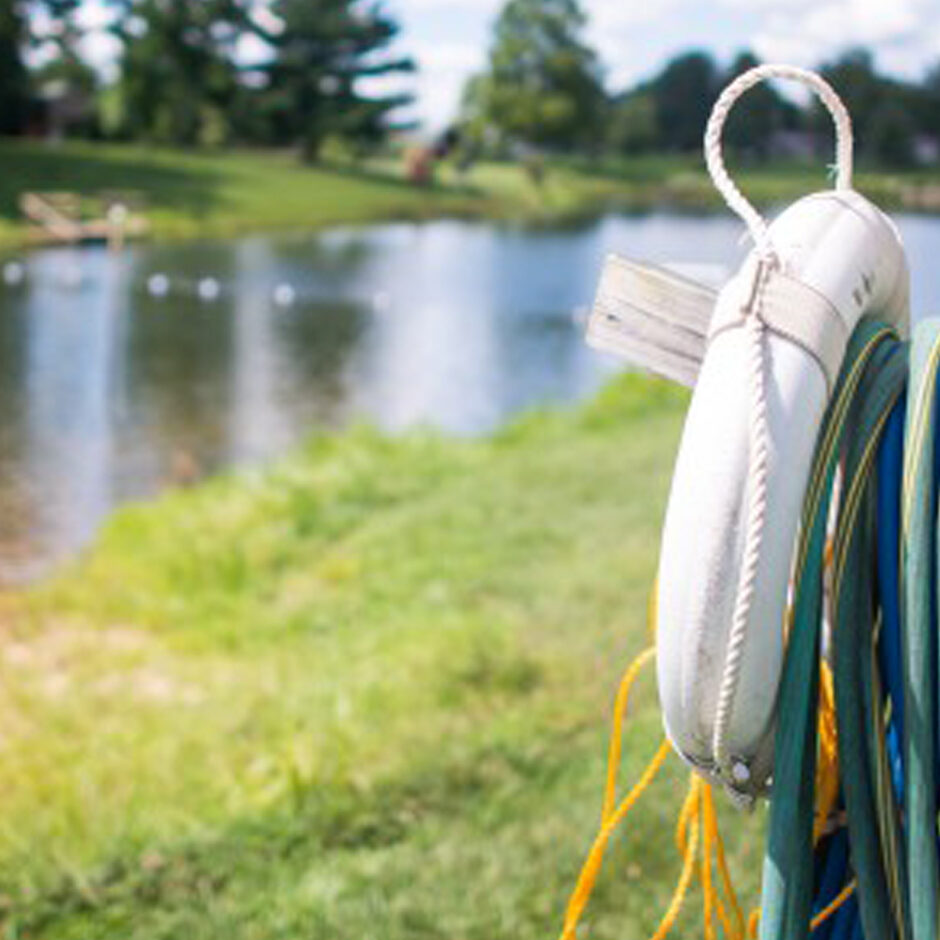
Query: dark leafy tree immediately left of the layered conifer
110 0 247 145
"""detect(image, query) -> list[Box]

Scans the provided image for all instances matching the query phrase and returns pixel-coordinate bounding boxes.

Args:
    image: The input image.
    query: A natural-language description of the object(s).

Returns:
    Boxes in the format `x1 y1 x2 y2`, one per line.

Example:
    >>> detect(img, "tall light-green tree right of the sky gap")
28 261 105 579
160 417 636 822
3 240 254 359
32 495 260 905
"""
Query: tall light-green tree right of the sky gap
470 0 607 150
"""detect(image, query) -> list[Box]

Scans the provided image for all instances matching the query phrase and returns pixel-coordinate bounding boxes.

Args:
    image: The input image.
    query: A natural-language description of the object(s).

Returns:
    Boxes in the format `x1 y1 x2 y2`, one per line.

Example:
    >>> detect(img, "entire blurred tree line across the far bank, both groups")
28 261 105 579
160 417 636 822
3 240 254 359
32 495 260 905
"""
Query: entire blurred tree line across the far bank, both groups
0 0 940 166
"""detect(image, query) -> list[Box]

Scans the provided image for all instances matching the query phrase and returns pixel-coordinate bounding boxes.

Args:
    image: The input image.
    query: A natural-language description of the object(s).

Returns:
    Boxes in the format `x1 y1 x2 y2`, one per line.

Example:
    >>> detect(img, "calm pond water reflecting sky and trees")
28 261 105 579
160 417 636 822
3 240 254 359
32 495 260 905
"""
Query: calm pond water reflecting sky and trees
0 215 940 582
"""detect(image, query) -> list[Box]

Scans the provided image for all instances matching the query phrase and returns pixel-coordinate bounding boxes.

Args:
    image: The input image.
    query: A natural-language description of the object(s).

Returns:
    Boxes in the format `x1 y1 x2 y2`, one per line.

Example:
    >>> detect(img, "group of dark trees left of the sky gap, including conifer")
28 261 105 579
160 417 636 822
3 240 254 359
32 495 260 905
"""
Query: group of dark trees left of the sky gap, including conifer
0 0 415 159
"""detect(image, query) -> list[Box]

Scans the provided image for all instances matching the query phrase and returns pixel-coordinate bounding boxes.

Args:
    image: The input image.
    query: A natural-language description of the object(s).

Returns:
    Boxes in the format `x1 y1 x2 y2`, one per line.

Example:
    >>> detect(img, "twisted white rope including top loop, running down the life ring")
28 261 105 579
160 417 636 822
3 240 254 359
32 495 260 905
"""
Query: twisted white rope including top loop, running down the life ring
705 65 853 793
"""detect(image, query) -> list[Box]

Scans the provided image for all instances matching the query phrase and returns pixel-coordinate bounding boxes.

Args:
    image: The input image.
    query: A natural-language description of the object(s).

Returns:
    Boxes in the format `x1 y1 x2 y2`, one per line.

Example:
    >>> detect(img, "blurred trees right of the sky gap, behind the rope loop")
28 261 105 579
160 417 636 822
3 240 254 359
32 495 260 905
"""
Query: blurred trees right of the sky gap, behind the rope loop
462 0 940 167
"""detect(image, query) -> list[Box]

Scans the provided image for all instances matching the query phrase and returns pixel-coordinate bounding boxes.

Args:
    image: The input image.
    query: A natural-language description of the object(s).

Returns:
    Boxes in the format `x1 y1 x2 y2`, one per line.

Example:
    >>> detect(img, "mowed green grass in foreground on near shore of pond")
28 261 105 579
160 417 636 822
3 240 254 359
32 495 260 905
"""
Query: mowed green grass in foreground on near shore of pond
0 376 761 940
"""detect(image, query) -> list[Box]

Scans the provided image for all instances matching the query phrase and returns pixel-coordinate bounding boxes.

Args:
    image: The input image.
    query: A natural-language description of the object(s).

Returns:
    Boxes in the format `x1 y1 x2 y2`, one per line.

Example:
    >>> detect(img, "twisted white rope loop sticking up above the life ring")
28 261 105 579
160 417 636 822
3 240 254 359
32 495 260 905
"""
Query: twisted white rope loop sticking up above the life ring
705 64 854 264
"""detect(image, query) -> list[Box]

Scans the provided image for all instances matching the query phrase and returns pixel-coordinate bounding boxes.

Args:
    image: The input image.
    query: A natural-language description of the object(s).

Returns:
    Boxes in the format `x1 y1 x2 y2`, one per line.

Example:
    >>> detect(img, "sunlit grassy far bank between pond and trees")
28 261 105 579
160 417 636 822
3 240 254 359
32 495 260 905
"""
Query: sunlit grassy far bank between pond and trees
0 141 940 247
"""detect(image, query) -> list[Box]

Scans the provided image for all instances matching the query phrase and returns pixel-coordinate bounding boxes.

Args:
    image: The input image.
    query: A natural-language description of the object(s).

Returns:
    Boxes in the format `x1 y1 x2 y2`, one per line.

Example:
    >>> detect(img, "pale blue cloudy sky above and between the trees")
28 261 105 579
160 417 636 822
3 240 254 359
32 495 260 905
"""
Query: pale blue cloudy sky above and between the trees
70 0 940 130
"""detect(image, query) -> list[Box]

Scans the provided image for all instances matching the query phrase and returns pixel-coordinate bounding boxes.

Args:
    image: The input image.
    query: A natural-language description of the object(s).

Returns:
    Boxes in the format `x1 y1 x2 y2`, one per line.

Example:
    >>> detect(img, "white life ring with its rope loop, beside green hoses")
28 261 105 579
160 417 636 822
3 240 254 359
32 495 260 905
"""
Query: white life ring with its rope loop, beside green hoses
657 66 909 801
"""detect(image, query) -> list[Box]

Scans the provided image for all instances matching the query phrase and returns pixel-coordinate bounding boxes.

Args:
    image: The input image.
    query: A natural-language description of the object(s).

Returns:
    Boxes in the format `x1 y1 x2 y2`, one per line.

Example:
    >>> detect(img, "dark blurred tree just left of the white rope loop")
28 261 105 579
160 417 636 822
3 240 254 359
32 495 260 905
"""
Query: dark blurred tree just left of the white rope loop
652 52 720 151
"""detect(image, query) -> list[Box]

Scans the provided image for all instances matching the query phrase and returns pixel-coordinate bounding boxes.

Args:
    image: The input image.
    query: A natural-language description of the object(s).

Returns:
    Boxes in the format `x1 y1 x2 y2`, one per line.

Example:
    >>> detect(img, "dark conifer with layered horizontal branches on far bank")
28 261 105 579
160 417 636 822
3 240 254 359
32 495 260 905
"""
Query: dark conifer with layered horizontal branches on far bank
246 0 414 160
